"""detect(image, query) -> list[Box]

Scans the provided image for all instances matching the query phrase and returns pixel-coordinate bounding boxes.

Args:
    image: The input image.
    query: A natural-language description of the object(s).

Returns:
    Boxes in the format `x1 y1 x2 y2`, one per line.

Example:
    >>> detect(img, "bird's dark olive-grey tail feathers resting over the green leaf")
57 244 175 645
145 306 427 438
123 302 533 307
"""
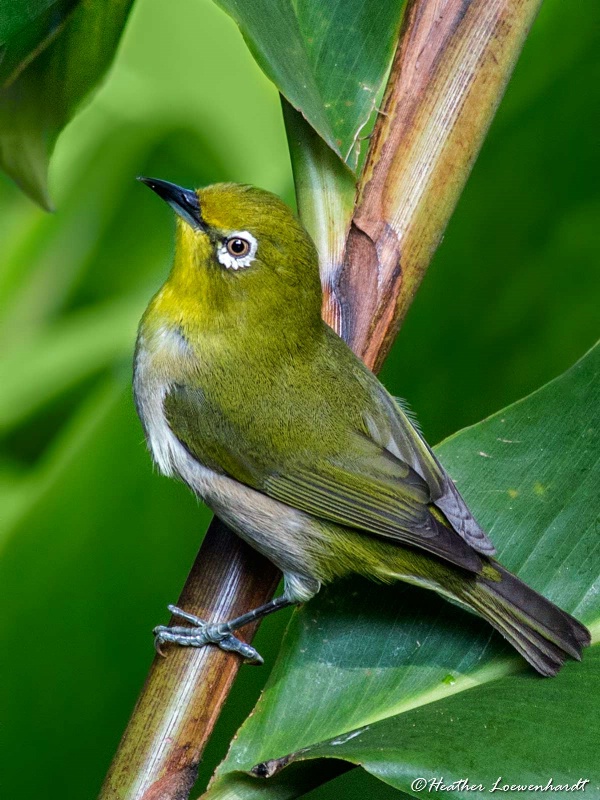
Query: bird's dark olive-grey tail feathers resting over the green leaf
460 561 590 675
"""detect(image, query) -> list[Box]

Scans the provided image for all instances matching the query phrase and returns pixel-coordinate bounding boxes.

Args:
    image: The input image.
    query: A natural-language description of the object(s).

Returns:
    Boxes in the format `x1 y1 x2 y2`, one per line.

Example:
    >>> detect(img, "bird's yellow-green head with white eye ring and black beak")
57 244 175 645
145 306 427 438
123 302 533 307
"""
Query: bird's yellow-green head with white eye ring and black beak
140 178 321 334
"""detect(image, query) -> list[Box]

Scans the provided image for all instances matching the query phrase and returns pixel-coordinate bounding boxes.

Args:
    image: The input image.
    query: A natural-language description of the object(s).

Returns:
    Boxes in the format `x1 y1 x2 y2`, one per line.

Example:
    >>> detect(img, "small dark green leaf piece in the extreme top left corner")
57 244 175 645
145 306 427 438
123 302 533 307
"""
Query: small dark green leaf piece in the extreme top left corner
0 0 80 86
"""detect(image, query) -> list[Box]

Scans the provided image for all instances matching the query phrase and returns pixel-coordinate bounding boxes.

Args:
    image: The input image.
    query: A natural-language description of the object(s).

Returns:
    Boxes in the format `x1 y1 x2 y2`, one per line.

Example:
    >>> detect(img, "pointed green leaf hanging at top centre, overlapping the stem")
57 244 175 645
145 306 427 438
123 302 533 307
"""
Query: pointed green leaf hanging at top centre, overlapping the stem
210 0 403 169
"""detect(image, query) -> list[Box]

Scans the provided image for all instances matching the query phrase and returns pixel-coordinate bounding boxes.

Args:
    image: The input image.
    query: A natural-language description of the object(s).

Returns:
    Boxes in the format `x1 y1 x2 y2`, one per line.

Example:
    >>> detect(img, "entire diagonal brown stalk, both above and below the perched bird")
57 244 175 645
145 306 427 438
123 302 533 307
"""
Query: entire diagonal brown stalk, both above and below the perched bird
100 0 541 800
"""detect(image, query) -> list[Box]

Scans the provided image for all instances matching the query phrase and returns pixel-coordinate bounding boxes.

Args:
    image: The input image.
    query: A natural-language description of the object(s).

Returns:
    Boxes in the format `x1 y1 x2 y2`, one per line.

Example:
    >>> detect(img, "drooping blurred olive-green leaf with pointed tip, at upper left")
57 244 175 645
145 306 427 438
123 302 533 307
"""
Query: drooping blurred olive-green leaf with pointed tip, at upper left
0 0 132 208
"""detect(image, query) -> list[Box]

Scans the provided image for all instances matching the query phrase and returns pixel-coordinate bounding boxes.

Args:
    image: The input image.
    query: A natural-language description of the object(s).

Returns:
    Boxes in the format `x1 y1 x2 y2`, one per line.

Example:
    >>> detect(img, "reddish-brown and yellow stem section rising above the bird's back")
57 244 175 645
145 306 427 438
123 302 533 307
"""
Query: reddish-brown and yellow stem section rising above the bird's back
338 0 541 370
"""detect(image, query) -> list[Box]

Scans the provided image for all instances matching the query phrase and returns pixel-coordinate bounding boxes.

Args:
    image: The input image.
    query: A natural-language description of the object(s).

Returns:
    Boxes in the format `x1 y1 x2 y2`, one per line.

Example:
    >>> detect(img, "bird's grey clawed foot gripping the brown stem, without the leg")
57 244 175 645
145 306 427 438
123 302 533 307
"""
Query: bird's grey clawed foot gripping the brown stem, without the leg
154 606 264 664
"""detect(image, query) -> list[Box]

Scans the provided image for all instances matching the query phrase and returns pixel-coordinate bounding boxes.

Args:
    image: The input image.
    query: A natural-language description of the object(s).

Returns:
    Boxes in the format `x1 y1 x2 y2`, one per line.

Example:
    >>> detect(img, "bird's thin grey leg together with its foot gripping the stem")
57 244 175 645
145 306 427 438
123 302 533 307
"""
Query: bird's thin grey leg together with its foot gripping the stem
154 595 293 664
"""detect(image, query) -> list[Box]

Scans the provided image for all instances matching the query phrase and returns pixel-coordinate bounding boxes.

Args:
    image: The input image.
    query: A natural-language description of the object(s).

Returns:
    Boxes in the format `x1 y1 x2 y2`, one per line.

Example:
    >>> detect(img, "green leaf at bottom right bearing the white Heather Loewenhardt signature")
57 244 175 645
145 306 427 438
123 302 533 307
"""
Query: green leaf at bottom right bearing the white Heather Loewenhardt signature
270 644 600 800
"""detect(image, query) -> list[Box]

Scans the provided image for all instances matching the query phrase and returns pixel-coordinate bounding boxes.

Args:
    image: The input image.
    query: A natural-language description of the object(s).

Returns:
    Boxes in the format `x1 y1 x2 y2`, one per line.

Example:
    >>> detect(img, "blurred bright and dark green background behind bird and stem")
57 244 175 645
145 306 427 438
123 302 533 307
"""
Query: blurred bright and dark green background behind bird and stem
0 0 600 800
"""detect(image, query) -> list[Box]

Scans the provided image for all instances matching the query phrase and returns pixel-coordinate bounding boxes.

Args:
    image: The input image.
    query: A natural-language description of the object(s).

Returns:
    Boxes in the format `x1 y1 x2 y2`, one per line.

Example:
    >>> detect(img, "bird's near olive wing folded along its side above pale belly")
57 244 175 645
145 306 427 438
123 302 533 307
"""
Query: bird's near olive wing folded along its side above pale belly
165 387 481 572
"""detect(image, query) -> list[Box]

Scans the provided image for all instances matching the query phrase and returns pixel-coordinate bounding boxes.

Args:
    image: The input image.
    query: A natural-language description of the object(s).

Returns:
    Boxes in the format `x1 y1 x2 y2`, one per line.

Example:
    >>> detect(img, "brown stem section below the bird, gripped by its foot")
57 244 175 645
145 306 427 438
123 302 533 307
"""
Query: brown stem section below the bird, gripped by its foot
100 518 280 800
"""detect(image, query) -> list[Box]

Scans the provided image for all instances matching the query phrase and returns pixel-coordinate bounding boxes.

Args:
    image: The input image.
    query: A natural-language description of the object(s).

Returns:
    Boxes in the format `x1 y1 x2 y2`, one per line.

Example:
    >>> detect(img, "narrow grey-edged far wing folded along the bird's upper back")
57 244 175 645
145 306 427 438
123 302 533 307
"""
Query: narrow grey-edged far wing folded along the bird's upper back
357 370 496 556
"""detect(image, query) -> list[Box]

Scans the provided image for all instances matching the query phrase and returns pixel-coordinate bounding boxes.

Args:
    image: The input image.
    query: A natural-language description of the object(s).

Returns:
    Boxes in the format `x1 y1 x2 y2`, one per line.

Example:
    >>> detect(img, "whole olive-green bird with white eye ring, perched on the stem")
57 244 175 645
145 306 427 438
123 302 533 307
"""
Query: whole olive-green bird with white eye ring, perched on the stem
134 178 590 675
